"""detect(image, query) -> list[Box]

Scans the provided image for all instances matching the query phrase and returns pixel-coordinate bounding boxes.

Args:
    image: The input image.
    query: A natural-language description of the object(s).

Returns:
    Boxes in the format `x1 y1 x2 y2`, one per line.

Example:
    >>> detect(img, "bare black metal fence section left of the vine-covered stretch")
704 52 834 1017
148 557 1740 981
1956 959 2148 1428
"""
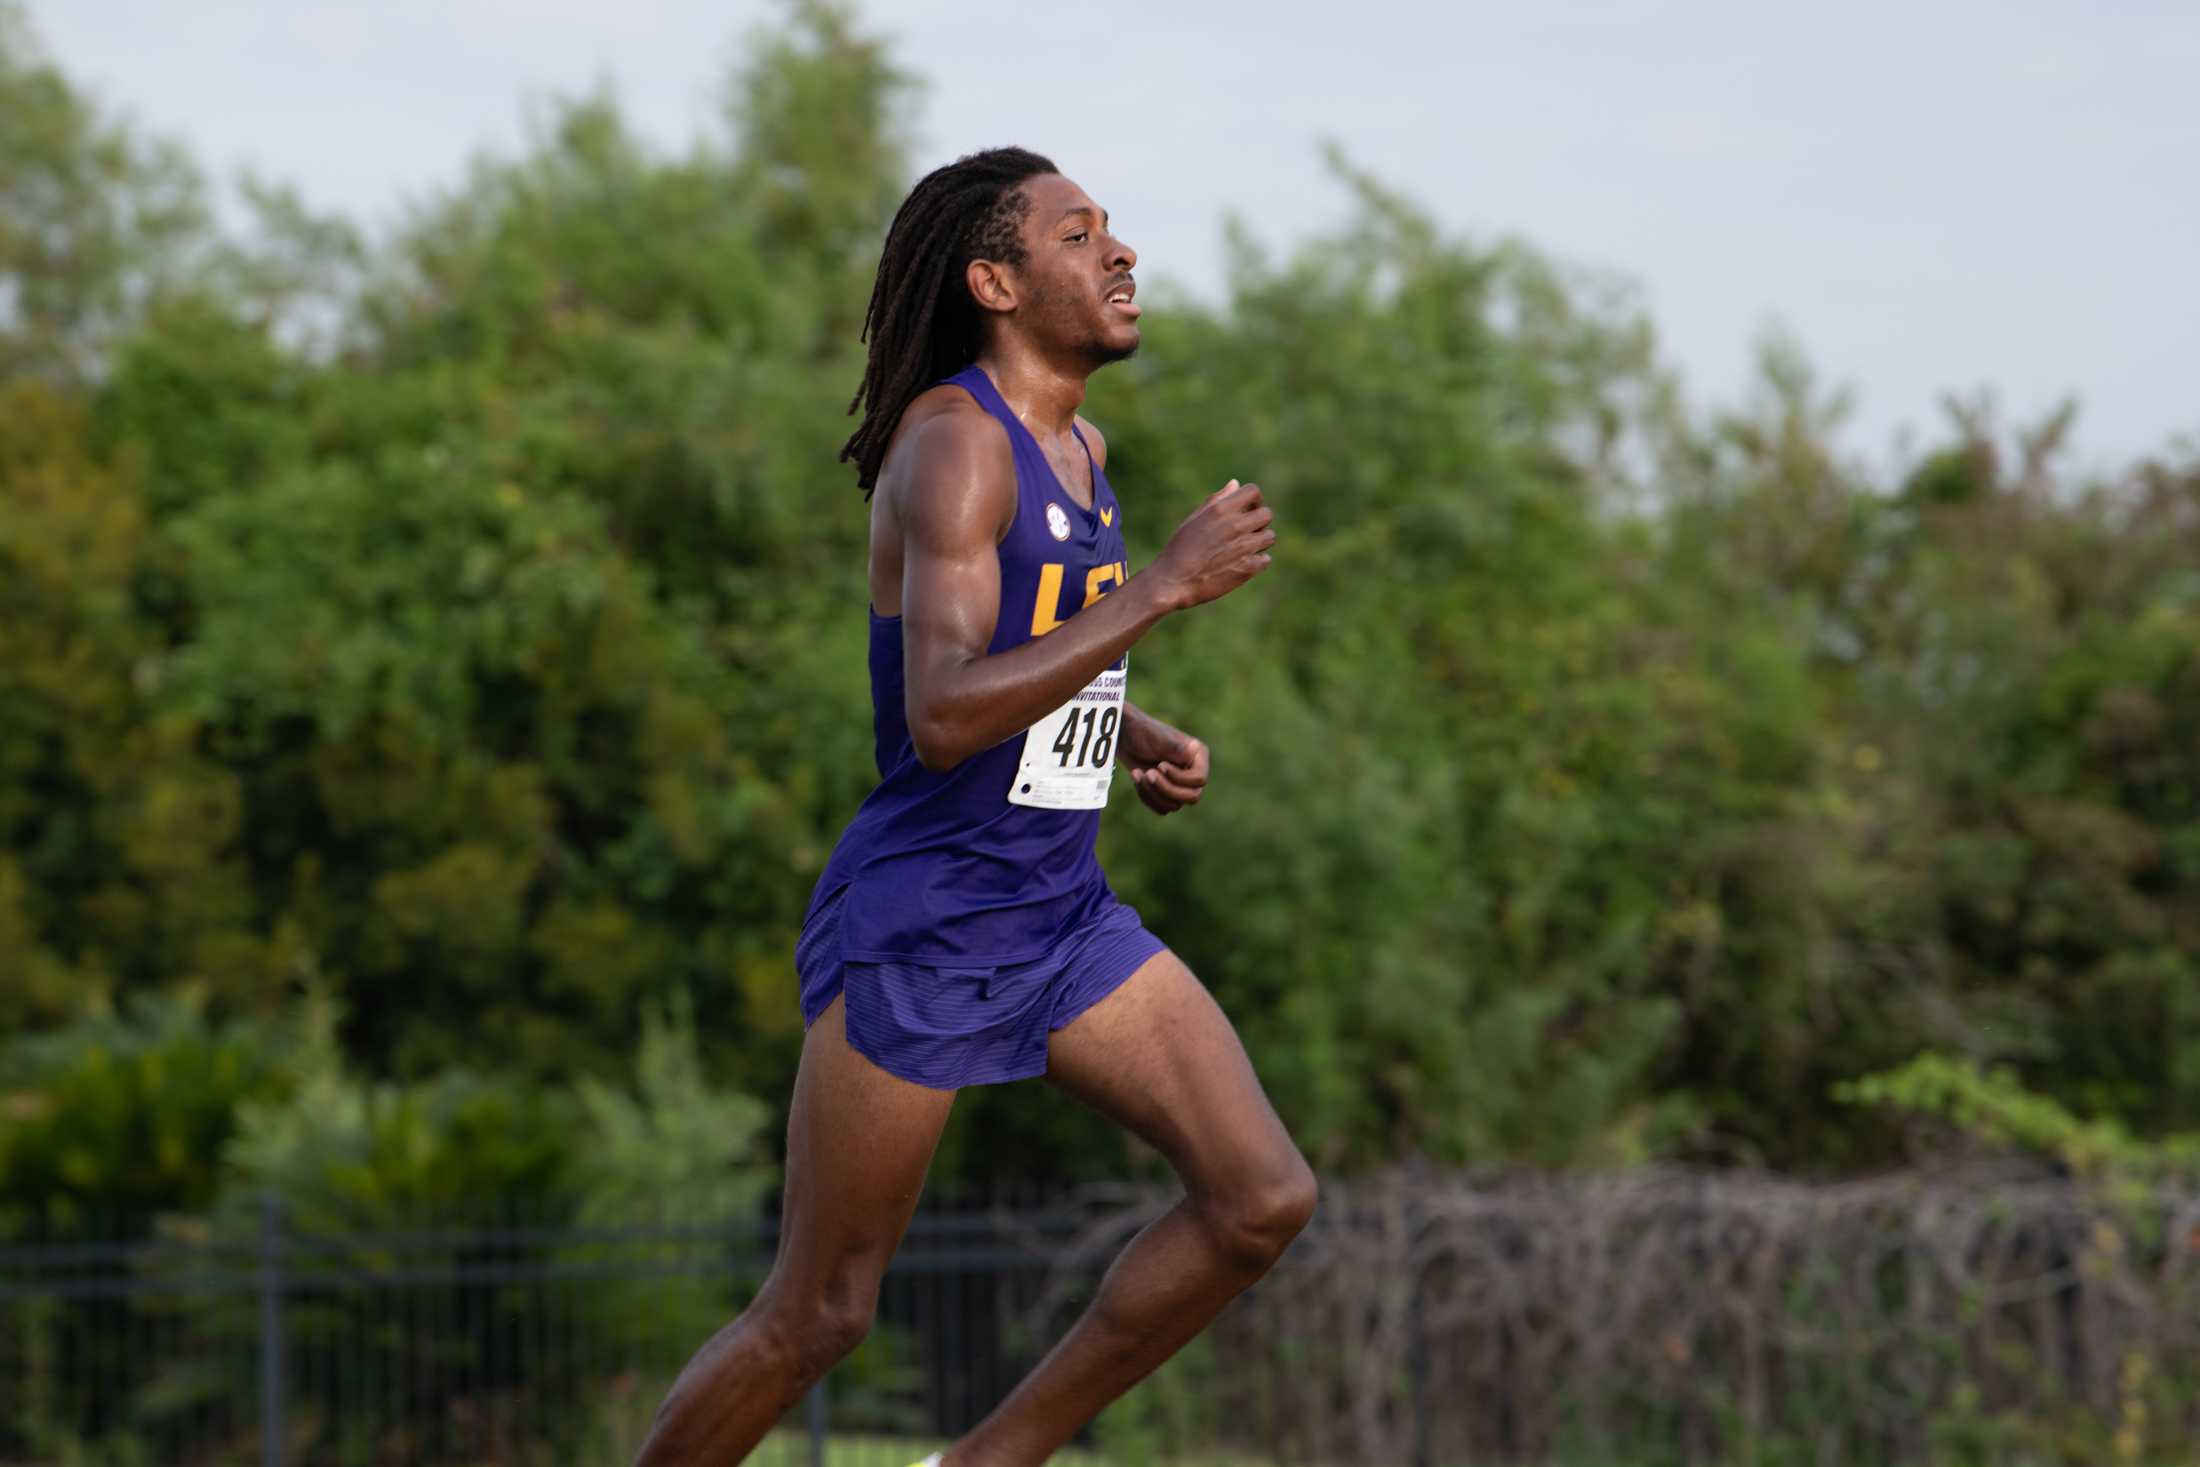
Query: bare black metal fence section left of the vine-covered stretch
0 1199 1100 1467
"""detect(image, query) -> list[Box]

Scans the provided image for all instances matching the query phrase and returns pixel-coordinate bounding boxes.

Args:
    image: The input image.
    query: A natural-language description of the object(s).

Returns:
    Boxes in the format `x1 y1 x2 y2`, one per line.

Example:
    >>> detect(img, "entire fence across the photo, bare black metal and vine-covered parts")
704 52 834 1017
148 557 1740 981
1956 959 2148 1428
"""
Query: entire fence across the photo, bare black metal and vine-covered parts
0 1168 2200 1467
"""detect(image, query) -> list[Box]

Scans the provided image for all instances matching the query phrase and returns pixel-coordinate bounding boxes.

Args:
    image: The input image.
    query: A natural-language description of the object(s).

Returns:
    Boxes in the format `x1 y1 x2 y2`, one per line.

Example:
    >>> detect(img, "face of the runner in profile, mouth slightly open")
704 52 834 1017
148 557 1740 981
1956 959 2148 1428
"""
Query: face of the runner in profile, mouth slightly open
1016 174 1140 367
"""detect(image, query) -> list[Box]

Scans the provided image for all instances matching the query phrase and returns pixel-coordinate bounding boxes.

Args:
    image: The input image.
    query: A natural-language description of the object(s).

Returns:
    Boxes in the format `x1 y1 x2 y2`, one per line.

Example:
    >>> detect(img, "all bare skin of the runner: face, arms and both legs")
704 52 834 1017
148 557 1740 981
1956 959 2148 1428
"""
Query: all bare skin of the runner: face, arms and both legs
636 163 1316 1467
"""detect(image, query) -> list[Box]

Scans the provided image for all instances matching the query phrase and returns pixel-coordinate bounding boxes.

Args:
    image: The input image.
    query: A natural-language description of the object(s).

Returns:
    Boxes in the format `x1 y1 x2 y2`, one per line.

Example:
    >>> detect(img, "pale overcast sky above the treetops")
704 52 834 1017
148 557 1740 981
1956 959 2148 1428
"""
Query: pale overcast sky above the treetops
29 0 2200 464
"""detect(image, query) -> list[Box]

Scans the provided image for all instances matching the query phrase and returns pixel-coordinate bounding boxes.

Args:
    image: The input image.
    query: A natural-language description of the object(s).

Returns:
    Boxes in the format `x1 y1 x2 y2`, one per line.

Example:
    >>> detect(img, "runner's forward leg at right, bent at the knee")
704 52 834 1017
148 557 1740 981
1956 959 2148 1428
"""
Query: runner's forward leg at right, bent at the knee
946 952 1313 1467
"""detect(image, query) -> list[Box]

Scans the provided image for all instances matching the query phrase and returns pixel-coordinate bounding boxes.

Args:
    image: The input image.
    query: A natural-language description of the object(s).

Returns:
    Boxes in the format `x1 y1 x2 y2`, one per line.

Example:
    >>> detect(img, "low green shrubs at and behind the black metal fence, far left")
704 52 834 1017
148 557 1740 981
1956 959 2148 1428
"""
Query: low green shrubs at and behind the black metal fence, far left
0 996 772 1460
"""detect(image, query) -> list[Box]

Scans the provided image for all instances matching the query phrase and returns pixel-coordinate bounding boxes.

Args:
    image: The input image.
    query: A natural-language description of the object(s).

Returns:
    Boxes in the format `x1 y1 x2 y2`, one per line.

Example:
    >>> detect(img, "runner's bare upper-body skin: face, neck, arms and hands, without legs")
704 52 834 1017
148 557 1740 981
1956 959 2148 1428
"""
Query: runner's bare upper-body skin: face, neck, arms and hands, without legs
869 174 1276 787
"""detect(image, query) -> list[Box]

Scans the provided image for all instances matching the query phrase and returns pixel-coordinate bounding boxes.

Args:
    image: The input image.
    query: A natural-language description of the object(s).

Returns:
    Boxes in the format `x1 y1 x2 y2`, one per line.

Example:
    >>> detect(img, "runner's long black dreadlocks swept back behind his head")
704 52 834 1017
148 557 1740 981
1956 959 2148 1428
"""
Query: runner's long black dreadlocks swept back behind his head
840 147 1060 499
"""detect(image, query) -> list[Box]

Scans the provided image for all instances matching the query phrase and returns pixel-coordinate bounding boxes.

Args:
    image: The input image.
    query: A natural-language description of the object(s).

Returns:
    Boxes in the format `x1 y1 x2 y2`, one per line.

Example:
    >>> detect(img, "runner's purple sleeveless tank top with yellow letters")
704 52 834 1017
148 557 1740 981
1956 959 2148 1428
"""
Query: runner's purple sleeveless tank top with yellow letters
805 365 1129 968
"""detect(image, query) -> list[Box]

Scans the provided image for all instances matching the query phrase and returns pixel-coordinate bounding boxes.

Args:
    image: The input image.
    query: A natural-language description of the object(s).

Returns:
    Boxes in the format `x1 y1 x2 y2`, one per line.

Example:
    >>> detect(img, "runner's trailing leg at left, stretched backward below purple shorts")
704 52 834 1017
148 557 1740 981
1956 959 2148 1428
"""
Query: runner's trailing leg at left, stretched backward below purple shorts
636 999 955 1467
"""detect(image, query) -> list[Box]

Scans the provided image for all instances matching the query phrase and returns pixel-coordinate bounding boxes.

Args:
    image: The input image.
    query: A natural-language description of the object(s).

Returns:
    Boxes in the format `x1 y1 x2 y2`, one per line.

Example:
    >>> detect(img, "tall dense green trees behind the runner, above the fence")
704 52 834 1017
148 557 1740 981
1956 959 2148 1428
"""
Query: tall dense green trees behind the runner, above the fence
0 4 2200 1205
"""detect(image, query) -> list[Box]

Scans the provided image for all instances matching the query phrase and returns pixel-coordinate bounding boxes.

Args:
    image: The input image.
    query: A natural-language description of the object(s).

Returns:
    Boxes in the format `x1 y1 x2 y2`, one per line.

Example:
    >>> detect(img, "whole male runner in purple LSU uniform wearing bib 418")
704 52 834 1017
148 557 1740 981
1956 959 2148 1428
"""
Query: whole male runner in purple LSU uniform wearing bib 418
638 147 1313 1467
